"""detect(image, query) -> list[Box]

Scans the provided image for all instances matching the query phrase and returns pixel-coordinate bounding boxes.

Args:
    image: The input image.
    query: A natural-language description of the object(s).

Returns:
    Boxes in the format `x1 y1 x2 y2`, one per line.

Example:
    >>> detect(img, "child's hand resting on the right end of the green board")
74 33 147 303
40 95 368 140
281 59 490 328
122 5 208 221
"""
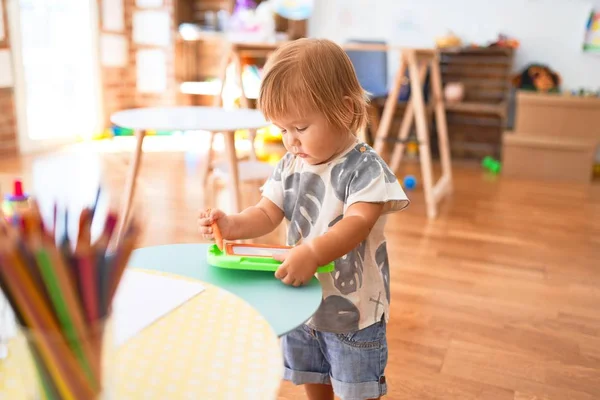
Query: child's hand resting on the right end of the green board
273 245 319 286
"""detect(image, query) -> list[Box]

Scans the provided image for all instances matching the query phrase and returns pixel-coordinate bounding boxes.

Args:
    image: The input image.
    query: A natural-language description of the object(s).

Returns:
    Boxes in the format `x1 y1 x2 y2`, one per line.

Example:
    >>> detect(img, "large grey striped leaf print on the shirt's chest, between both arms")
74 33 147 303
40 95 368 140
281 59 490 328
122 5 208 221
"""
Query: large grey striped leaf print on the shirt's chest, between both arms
283 172 325 246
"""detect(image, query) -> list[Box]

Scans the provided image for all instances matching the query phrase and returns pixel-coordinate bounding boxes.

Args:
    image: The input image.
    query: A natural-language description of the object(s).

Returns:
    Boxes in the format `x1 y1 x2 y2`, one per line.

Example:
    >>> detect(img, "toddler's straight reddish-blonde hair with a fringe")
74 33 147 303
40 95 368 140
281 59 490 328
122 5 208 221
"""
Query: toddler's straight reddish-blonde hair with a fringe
258 38 368 134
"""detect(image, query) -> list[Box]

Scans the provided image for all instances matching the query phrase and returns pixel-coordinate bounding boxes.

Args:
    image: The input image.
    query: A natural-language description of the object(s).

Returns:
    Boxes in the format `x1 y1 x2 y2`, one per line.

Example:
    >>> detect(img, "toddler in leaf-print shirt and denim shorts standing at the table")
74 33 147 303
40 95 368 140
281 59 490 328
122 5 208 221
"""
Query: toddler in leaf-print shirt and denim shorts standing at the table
198 39 409 400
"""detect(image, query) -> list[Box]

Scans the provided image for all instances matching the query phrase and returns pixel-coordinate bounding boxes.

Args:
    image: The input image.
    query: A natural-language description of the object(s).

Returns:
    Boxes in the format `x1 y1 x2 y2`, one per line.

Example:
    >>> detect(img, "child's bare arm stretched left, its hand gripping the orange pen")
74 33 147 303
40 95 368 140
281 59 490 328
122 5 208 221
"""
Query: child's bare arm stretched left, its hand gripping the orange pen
198 197 283 240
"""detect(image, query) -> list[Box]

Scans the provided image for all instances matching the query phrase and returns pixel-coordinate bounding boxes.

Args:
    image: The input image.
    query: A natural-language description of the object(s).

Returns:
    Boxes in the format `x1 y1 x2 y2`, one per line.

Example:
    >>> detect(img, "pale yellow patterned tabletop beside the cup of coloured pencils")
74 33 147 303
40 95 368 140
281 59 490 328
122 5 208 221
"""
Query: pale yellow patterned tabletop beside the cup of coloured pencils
0 272 283 400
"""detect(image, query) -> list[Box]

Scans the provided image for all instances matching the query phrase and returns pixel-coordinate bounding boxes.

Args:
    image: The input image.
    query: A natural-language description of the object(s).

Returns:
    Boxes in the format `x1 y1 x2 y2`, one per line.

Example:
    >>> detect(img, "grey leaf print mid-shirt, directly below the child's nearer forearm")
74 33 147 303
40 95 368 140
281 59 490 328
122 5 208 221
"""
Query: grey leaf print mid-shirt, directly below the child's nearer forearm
329 215 367 295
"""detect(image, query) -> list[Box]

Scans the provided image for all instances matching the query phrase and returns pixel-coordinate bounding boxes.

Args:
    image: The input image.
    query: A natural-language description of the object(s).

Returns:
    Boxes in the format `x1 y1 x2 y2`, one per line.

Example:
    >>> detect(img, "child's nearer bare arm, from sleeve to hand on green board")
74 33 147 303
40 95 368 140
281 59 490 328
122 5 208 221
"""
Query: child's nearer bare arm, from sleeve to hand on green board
275 203 383 286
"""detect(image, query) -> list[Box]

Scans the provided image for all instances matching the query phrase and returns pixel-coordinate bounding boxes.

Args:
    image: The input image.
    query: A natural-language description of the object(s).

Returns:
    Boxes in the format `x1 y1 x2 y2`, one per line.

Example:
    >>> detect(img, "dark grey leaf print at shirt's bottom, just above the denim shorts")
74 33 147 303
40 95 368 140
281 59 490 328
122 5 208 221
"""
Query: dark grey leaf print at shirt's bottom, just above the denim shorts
312 295 360 332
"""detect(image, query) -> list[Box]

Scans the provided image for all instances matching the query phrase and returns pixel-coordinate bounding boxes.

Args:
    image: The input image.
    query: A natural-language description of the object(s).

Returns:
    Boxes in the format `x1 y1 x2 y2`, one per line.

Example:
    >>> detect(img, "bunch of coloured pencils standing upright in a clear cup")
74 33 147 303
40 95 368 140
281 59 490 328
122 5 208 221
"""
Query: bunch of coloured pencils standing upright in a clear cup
0 190 140 400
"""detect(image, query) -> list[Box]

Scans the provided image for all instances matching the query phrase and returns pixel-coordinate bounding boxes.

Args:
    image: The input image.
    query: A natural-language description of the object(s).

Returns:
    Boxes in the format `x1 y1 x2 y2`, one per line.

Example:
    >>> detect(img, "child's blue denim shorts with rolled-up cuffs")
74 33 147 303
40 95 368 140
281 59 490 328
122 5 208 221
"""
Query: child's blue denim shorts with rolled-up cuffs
282 319 388 400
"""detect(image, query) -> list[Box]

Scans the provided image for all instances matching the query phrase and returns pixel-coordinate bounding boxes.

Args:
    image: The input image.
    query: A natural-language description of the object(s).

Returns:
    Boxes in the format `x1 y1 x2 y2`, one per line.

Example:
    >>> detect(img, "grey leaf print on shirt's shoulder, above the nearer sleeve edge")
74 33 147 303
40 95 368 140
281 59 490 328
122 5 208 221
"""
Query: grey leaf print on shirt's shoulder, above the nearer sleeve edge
331 144 388 203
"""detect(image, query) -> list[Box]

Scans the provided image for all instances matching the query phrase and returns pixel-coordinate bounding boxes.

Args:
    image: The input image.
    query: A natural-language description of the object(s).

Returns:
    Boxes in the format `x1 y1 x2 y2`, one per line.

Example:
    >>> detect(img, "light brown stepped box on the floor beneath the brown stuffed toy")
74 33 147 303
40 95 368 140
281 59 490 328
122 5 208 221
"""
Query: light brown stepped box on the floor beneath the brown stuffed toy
502 92 600 183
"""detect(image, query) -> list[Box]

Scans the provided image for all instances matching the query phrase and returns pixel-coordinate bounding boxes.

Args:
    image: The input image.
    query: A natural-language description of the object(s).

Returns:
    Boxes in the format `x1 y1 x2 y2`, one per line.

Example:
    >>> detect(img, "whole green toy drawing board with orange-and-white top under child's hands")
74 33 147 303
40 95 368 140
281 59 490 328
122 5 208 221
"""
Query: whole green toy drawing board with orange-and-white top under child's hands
206 242 335 273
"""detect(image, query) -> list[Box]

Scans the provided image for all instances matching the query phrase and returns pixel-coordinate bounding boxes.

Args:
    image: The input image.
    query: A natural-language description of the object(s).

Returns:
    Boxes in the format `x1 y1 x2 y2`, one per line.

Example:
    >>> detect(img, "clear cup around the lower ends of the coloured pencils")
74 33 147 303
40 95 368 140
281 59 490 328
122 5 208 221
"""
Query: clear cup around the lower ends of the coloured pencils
12 316 117 400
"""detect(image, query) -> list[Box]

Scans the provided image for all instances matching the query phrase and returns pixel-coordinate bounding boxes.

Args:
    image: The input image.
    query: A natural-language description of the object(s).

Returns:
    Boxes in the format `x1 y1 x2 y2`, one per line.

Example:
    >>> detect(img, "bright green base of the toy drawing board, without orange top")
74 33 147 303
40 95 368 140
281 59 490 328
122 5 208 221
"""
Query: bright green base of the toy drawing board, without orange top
206 244 335 273
